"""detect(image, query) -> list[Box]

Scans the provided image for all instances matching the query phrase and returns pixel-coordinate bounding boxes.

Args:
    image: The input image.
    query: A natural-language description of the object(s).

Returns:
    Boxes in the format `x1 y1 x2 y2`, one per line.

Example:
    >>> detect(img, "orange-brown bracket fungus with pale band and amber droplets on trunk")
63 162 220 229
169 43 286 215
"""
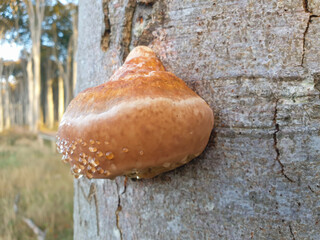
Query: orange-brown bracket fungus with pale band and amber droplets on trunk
57 46 213 179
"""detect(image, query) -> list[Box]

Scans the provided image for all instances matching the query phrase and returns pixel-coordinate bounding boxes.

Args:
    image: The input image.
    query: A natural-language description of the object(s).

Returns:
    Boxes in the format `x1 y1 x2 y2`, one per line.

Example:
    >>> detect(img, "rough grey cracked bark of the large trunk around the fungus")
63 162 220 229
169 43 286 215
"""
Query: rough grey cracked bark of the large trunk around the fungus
74 0 320 240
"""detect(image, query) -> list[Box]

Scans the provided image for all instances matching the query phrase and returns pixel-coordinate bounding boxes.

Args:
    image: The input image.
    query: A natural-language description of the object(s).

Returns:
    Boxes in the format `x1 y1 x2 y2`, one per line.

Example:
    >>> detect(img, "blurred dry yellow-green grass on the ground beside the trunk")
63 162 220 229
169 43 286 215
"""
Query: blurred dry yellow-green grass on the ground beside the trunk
0 133 73 240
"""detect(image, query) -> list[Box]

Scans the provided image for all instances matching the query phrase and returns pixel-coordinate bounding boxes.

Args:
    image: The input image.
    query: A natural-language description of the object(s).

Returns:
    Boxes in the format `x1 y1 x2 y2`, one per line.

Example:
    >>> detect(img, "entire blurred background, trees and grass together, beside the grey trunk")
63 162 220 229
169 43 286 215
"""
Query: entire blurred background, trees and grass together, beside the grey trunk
0 0 78 239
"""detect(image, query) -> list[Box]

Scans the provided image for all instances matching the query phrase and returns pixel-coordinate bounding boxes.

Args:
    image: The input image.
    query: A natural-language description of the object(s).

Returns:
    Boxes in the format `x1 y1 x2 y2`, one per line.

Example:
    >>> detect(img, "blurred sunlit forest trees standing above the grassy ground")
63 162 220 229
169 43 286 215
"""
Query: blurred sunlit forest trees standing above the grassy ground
0 0 77 133
